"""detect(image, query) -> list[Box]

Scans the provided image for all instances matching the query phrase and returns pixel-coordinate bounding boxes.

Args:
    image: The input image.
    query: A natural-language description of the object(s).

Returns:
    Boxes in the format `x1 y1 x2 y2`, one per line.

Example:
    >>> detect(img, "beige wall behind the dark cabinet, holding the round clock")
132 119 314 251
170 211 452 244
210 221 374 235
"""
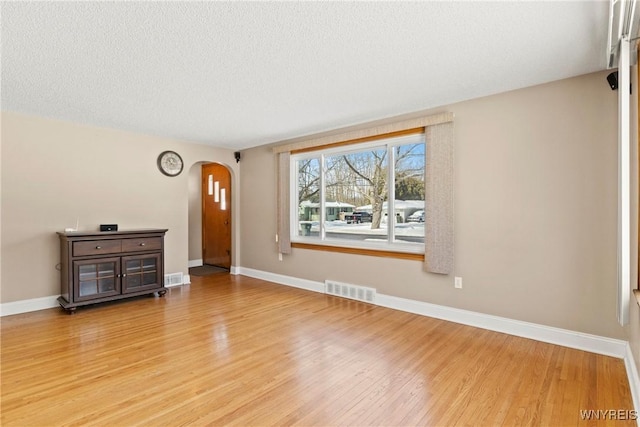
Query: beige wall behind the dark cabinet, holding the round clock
0 112 239 303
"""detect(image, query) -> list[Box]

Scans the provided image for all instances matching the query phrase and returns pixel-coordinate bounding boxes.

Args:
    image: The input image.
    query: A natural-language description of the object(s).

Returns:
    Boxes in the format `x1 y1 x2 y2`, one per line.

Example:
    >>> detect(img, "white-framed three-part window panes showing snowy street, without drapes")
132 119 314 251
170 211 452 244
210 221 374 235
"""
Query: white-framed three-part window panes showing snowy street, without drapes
289 132 426 253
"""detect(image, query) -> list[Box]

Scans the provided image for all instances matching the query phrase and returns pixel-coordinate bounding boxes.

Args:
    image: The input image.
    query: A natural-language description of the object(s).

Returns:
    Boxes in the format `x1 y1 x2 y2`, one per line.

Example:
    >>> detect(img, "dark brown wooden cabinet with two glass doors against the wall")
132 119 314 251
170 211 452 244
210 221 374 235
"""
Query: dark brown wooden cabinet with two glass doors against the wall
58 229 167 313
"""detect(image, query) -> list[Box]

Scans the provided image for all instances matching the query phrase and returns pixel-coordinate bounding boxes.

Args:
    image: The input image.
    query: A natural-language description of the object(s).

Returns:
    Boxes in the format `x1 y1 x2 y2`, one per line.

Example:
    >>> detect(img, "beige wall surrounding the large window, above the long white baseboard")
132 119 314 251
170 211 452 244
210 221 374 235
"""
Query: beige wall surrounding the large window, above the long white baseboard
241 72 627 339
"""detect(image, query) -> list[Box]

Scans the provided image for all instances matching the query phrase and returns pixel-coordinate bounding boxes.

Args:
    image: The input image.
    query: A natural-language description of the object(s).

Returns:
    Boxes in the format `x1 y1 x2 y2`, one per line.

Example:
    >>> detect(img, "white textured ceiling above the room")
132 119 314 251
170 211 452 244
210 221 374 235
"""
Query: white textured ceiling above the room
1 1 608 149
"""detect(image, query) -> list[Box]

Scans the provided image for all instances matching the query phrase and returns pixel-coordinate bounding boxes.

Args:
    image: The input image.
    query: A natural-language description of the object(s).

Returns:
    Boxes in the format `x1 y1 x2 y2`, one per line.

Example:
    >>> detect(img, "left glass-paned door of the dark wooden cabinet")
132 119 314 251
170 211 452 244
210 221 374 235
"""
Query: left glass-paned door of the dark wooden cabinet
73 258 120 301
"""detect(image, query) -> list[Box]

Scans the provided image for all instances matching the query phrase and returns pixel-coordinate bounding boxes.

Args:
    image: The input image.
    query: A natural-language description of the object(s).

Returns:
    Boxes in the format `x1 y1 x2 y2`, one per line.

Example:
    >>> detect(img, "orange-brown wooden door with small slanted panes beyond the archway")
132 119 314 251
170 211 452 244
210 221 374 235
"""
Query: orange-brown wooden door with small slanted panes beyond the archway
202 163 231 269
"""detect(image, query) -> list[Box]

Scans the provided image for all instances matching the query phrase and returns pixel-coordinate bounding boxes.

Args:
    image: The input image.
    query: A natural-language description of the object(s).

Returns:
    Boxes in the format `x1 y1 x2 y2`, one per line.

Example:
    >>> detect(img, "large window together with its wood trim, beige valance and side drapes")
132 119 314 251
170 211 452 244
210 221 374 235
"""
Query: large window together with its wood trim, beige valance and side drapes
273 112 454 274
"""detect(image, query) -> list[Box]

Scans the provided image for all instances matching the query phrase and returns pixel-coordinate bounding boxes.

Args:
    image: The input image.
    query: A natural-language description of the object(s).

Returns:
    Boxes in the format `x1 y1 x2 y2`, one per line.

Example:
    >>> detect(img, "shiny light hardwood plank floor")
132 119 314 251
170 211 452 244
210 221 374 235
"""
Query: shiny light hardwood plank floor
0 274 635 426
